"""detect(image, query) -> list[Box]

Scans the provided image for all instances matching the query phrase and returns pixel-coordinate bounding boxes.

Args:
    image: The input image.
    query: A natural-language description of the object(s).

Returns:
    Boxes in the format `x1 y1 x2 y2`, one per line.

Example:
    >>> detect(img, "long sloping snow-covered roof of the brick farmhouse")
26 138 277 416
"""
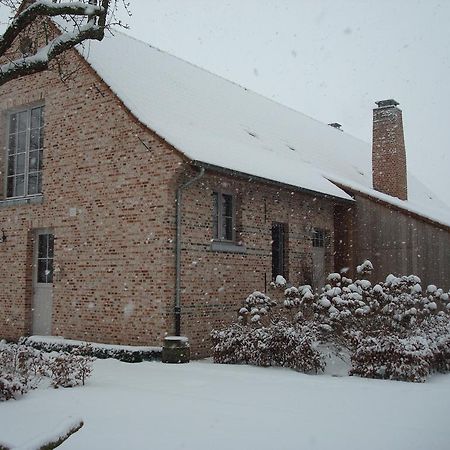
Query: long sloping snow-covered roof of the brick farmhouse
85 31 450 226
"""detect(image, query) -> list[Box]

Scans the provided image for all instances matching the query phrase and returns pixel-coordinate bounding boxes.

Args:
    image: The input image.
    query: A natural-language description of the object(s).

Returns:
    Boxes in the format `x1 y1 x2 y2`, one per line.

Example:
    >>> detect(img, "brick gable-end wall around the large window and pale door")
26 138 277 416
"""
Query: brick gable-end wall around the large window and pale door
0 48 182 344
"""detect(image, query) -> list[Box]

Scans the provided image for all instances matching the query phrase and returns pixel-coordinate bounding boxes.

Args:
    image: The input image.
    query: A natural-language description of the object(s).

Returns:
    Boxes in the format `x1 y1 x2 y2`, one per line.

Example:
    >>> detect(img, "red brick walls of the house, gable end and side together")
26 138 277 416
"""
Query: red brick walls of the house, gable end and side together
0 47 334 356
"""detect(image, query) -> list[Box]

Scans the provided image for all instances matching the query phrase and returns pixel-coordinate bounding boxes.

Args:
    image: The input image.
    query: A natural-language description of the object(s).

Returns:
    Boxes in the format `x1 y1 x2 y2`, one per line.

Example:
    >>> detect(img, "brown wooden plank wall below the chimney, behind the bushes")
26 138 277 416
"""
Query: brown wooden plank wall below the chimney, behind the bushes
353 195 450 289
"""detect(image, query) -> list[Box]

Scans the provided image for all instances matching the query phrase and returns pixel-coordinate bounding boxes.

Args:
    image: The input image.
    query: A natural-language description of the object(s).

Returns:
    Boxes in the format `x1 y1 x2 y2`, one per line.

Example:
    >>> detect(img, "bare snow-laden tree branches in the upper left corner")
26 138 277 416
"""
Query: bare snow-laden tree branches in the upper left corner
0 0 129 86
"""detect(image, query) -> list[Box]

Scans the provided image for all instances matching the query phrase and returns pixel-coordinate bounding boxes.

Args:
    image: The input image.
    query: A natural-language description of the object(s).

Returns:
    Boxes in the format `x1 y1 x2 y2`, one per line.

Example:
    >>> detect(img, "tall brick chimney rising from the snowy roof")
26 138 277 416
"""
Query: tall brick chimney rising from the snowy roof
372 99 408 200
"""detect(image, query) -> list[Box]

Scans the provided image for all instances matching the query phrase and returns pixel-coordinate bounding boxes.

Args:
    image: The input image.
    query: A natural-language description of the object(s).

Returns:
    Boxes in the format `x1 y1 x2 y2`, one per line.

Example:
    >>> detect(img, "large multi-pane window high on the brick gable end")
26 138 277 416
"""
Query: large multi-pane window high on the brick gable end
6 106 44 197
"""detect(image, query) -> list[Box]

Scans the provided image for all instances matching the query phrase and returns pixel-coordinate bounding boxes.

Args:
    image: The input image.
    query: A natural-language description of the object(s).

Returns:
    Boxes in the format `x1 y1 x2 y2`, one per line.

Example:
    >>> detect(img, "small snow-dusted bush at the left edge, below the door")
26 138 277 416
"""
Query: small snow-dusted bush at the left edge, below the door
0 341 93 401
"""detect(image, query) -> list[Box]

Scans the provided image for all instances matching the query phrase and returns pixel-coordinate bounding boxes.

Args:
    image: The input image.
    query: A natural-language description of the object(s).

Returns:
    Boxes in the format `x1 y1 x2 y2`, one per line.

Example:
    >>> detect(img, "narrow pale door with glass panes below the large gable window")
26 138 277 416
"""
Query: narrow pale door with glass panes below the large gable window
32 230 54 336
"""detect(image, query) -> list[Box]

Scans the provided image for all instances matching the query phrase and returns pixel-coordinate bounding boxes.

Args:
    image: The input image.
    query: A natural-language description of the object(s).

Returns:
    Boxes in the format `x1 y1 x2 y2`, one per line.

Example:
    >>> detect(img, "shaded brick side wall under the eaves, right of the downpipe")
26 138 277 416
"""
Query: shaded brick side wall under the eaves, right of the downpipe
175 172 334 356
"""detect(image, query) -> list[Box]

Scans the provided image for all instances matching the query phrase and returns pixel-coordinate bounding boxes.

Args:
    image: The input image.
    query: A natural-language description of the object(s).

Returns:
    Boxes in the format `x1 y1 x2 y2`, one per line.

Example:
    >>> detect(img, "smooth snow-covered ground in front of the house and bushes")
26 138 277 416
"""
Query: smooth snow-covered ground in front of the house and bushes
0 359 450 450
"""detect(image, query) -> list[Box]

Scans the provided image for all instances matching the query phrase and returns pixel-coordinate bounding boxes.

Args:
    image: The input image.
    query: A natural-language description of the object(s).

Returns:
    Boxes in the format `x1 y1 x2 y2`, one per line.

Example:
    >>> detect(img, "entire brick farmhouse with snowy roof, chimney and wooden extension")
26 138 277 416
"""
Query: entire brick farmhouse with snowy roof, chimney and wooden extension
0 24 450 356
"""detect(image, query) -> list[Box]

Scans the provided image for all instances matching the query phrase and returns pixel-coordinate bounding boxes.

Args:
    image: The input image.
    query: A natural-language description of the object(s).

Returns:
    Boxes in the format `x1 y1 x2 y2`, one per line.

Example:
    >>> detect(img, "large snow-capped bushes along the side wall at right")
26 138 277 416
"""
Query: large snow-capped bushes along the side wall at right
212 261 450 382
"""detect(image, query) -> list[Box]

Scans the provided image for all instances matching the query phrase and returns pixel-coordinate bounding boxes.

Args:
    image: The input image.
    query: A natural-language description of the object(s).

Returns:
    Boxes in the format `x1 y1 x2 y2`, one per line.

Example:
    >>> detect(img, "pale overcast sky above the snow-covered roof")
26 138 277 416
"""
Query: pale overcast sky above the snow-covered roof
3 0 450 203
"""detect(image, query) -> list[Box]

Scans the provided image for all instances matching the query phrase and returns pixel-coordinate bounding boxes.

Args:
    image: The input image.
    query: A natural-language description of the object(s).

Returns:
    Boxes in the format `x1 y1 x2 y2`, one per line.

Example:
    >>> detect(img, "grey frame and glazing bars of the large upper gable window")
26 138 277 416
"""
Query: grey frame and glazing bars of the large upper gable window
2 101 45 201
